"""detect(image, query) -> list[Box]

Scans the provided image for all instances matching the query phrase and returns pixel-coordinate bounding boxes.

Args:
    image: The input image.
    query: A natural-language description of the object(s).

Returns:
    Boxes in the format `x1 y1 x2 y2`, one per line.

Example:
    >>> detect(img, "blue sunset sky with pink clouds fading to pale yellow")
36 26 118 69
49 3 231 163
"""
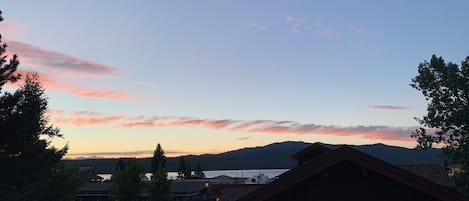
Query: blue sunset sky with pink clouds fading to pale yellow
0 0 469 158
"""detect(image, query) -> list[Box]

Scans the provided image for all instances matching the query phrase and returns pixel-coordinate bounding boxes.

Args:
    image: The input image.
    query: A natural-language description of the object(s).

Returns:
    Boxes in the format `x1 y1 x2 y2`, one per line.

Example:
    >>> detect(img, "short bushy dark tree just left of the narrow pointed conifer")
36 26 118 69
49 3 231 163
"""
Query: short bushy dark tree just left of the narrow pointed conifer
110 159 145 201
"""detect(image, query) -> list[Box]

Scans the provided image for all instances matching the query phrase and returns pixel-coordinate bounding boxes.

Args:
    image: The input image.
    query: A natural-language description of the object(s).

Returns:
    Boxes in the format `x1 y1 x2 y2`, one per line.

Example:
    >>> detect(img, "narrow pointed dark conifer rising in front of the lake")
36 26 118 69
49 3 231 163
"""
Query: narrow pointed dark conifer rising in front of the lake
150 144 172 201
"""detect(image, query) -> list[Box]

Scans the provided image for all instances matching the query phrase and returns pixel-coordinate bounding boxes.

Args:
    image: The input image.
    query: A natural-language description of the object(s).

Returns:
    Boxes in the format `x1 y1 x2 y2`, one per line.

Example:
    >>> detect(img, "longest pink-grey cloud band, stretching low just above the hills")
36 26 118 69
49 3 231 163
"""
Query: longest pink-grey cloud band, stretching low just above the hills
50 111 416 141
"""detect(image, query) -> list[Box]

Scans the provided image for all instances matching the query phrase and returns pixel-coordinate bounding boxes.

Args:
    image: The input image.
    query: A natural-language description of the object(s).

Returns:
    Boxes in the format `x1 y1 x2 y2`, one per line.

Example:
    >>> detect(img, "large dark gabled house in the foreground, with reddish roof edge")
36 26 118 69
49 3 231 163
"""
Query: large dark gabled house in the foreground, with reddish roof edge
238 143 469 201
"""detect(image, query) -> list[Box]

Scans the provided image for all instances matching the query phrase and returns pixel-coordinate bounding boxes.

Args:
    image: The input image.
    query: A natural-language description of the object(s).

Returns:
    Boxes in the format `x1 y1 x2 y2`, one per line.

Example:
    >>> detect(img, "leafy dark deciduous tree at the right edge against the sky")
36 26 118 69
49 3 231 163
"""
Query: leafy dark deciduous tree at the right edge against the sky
411 55 469 195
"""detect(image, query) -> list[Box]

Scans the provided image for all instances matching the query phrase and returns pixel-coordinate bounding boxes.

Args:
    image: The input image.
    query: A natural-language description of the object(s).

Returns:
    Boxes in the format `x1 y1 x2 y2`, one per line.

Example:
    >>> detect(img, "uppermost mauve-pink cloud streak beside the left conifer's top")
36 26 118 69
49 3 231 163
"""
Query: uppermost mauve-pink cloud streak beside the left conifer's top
6 40 118 77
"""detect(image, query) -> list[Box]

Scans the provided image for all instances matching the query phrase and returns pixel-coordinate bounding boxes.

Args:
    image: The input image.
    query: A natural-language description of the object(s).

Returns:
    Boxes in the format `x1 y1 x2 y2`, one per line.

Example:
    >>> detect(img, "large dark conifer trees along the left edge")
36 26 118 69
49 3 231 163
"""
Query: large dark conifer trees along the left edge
0 12 79 201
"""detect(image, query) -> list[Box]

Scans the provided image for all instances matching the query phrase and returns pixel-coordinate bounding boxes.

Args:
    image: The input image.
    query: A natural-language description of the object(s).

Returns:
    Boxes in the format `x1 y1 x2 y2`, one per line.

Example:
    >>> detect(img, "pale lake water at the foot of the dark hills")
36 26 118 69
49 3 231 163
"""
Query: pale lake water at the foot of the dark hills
98 169 288 180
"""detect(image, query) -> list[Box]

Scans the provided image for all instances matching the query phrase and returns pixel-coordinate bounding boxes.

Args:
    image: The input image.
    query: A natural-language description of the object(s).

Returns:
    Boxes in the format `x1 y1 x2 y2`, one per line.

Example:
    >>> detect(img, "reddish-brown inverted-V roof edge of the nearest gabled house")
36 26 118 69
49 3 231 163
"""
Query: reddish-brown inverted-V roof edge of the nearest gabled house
239 146 468 201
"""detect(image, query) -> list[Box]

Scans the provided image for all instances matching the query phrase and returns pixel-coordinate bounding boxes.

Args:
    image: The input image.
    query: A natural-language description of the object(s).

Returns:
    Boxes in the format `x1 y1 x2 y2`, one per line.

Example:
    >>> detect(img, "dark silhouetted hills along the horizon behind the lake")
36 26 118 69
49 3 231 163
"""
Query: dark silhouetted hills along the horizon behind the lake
65 141 442 173
